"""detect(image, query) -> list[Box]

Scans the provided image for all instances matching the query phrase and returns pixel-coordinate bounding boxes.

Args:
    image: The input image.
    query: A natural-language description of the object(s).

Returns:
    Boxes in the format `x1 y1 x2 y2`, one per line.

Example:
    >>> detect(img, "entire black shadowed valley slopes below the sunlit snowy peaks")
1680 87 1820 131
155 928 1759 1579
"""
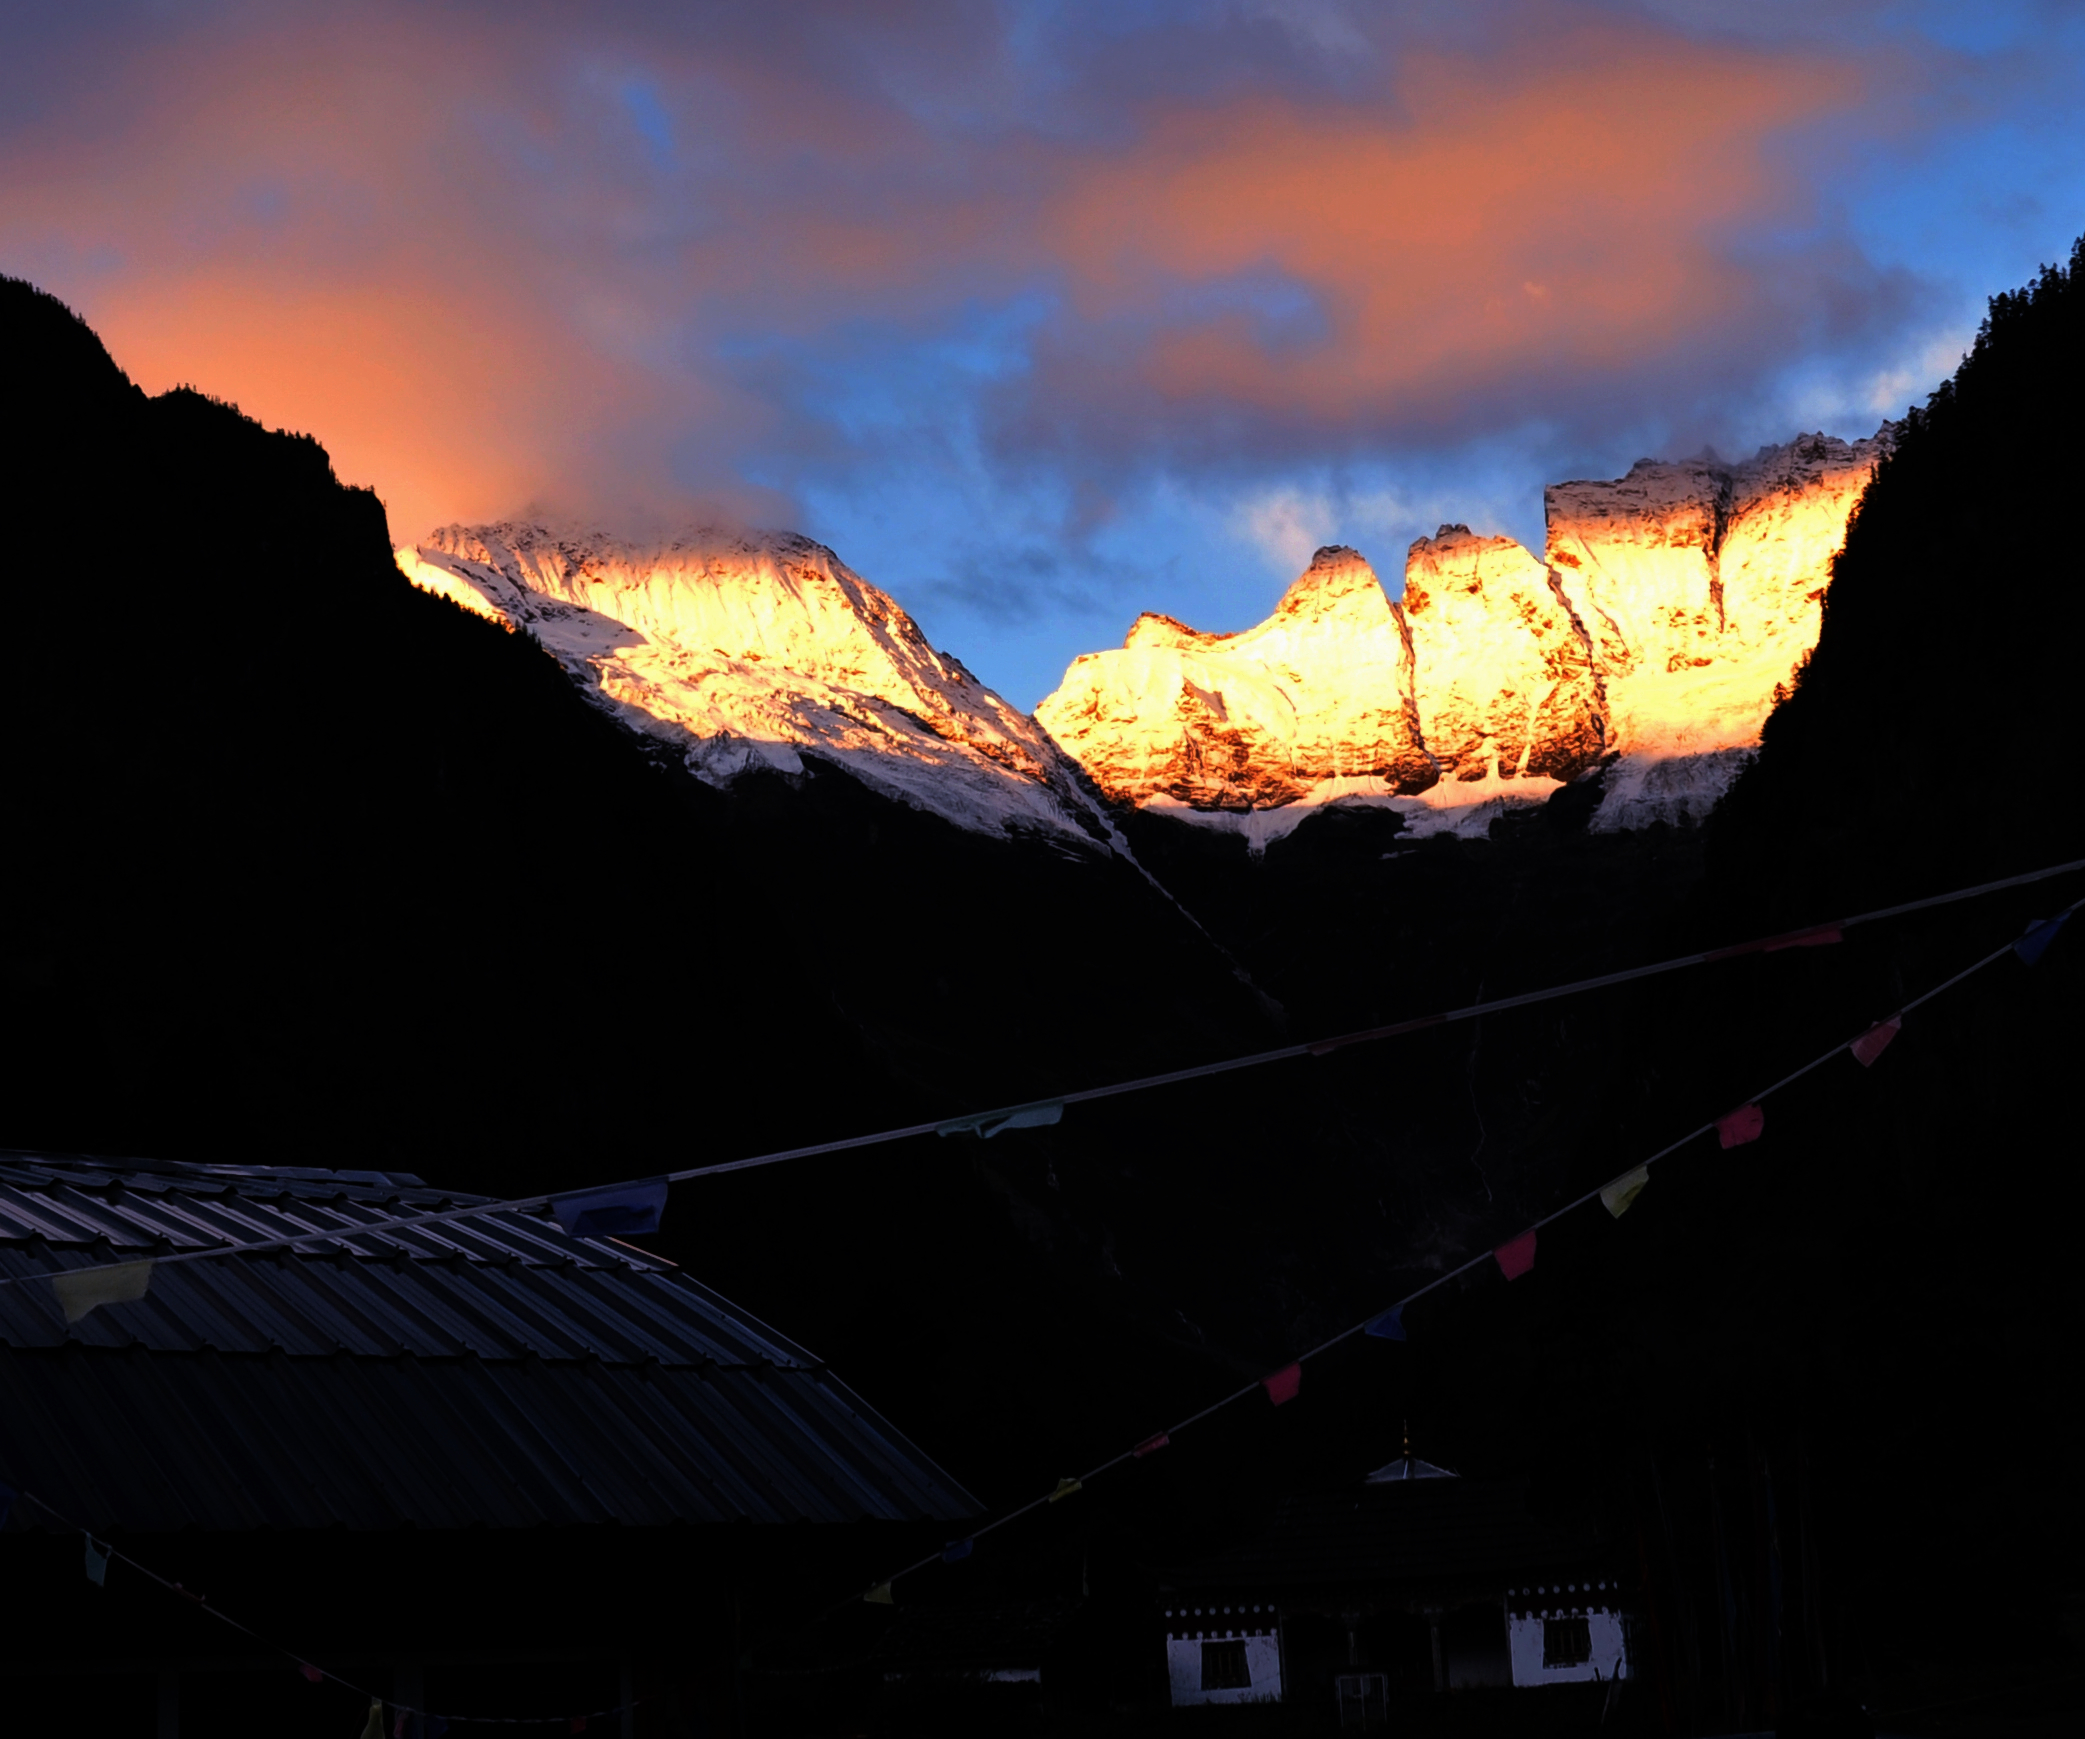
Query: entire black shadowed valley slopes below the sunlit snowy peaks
0 259 2085 1731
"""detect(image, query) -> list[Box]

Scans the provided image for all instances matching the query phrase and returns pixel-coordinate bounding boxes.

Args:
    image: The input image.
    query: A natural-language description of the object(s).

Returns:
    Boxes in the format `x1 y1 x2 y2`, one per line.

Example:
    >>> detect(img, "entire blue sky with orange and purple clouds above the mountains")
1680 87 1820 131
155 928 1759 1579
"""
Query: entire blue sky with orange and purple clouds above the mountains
0 0 2085 707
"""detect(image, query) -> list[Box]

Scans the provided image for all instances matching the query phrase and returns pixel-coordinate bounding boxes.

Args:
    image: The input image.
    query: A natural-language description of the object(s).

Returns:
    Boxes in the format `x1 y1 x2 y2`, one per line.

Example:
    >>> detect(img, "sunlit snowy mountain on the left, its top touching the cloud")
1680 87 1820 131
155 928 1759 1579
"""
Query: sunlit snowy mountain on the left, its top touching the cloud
398 525 1107 844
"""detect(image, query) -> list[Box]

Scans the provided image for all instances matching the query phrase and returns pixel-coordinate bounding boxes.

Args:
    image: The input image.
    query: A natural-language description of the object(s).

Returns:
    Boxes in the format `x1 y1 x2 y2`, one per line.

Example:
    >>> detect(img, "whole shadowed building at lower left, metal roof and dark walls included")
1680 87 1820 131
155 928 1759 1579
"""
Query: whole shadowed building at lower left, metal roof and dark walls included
0 1153 976 1739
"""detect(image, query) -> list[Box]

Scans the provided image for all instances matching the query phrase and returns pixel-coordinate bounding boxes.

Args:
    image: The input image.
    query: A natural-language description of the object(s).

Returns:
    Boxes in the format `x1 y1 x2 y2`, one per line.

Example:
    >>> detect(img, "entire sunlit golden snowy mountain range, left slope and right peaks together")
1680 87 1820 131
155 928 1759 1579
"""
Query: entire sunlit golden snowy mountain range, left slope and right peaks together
398 425 1891 851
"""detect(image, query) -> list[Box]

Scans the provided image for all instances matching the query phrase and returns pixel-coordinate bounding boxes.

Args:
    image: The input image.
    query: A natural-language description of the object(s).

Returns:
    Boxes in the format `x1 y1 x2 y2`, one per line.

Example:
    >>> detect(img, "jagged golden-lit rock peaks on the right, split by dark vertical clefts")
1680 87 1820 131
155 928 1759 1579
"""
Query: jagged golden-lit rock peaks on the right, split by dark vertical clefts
1036 430 1889 847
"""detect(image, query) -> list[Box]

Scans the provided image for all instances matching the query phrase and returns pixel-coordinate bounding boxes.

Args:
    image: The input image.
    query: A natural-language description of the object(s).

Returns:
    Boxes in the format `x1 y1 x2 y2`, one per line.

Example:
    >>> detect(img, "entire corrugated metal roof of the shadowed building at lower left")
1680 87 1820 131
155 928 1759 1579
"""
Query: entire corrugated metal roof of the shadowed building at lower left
0 1155 978 1528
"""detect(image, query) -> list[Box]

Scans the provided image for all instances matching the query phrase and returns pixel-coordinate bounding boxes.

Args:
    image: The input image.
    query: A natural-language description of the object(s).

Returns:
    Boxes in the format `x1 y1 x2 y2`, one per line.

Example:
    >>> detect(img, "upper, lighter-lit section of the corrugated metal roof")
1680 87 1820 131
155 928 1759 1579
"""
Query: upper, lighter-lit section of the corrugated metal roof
0 1155 821 1368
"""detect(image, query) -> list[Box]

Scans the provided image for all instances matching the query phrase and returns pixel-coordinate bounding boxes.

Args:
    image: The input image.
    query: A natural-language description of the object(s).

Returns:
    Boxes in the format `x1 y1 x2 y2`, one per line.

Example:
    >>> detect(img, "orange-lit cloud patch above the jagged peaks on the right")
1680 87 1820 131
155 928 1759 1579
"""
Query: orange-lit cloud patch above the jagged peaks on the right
1051 33 1860 423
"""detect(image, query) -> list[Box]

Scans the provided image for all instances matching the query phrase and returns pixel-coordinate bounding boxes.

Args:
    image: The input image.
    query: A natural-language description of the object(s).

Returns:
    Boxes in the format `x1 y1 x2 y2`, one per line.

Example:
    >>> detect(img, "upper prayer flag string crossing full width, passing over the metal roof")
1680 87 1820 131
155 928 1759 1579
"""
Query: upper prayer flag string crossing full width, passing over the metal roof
20 857 2085 1322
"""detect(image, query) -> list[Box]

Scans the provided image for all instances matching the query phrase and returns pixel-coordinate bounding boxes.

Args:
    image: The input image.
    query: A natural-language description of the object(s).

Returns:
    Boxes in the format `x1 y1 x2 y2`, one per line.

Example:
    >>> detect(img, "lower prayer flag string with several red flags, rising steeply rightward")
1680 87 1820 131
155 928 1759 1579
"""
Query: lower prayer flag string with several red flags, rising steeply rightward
819 901 2085 1616
